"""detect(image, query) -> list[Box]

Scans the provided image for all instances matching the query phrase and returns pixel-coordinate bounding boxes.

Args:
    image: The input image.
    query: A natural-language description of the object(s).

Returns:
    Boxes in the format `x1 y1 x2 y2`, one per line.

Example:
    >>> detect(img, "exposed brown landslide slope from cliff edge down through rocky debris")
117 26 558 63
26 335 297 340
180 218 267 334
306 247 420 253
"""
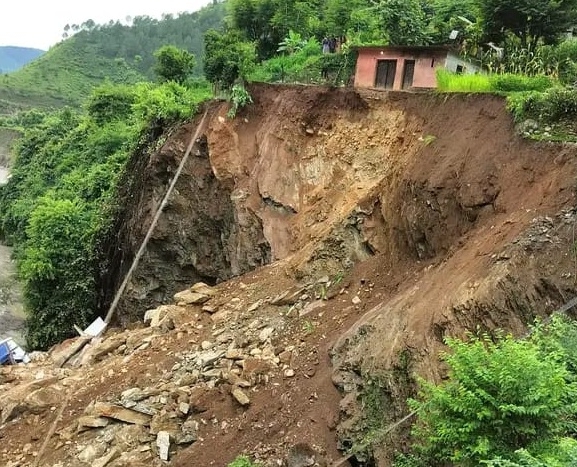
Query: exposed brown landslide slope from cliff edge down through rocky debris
0 86 577 467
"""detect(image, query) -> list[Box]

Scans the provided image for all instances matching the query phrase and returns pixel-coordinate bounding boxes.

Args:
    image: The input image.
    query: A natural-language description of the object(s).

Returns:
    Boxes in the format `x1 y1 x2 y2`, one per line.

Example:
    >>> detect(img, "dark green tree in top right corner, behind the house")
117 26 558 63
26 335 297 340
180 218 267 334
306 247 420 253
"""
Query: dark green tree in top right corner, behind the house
477 0 577 47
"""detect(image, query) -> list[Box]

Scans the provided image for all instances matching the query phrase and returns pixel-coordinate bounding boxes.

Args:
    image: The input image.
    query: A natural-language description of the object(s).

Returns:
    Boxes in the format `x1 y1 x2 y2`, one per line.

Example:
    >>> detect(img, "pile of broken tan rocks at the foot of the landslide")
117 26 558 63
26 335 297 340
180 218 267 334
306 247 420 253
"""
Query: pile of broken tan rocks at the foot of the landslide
0 277 344 467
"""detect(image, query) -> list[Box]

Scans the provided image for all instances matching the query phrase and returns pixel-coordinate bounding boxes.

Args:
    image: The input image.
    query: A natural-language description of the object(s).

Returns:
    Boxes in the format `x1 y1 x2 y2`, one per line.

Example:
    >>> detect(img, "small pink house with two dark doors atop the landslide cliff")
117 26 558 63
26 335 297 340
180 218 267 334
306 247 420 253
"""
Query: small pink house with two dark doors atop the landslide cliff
355 46 481 90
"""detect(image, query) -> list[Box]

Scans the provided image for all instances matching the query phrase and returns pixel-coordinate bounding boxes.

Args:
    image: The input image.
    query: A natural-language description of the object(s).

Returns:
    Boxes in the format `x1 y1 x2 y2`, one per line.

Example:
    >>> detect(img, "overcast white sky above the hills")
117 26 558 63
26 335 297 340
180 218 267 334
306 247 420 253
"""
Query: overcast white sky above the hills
0 0 210 50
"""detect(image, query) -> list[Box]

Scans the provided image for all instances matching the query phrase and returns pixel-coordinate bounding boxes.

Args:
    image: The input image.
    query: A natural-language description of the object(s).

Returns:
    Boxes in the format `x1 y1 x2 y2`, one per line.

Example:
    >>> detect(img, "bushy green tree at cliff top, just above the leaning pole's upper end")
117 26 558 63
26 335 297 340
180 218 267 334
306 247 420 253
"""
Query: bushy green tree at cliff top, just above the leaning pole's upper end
204 30 256 88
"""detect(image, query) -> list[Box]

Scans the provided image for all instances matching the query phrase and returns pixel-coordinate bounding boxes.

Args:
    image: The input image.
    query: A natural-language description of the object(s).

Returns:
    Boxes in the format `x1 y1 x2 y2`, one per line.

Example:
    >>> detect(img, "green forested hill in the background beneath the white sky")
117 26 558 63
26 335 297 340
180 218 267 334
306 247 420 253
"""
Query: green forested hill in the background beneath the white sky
0 3 225 114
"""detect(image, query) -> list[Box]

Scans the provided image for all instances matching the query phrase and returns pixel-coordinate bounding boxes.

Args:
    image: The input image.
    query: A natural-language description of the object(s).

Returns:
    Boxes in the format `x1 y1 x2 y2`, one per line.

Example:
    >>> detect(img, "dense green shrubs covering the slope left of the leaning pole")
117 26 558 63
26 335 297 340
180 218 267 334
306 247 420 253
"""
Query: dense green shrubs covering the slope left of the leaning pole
0 82 210 349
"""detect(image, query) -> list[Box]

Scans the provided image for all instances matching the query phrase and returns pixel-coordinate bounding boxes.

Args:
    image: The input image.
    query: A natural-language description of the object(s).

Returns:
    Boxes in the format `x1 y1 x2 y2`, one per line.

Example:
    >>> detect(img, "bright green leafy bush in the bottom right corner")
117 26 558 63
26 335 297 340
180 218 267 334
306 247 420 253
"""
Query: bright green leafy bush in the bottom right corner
410 318 577 466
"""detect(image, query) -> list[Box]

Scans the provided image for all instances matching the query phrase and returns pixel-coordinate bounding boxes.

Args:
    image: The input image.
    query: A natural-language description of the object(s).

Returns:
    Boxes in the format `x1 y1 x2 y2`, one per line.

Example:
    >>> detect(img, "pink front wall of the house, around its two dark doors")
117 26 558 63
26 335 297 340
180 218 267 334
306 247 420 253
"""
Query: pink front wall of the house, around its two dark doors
355 47 447 90
